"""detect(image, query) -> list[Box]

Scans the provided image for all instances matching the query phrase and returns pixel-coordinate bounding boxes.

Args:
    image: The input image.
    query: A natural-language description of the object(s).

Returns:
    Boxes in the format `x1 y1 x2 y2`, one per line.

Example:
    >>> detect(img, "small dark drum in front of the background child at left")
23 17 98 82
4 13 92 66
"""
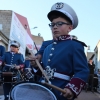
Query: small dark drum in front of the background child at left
1 72 18 83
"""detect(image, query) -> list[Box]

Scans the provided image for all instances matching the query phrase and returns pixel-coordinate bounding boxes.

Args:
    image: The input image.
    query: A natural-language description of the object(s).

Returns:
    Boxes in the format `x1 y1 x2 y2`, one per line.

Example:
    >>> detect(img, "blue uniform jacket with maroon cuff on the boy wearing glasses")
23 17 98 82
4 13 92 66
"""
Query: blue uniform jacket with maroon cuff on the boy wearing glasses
42 39 89 100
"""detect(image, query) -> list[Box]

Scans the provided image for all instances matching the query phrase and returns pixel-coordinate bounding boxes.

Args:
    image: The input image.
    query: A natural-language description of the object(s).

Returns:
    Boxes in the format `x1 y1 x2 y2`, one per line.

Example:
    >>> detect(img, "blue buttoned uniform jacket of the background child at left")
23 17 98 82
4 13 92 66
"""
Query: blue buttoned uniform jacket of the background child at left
1 52 24 68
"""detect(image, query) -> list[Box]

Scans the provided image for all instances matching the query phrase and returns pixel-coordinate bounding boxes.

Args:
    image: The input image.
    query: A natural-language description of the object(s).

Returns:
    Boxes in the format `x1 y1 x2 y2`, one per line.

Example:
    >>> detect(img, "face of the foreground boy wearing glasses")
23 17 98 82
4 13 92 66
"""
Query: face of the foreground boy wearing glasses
51 17 73 37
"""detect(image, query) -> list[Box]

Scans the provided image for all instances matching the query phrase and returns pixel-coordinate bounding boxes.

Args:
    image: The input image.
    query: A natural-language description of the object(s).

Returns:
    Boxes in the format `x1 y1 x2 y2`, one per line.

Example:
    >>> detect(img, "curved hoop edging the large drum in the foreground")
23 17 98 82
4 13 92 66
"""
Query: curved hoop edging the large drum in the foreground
10 81 57 100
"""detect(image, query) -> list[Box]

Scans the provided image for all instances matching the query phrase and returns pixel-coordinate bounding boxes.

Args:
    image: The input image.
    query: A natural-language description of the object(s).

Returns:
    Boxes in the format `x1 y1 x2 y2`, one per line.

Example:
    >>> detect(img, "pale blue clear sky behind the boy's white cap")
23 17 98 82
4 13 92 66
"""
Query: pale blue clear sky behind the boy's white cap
0 0 100 51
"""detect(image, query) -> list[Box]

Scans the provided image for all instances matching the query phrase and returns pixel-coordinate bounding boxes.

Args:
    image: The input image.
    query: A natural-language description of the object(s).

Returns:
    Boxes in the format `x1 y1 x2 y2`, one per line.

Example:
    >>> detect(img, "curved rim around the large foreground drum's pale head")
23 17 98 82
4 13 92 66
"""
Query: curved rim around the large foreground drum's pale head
9 81 58 100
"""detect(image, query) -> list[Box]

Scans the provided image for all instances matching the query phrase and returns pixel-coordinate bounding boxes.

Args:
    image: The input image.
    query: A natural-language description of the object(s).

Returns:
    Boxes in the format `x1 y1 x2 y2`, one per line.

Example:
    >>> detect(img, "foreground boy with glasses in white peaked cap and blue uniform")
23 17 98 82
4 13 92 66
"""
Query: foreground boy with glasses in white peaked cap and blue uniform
34 2 89 100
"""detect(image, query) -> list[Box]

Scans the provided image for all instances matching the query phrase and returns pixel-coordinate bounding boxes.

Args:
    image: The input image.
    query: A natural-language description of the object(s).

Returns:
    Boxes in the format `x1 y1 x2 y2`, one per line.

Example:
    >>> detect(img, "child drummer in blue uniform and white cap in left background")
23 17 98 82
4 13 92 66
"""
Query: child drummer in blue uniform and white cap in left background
0 41 24 100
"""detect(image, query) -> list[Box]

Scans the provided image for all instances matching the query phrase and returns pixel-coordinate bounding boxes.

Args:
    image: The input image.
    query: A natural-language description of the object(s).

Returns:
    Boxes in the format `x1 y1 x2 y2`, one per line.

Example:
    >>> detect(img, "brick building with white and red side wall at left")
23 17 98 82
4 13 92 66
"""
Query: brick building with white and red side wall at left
0 10 43 57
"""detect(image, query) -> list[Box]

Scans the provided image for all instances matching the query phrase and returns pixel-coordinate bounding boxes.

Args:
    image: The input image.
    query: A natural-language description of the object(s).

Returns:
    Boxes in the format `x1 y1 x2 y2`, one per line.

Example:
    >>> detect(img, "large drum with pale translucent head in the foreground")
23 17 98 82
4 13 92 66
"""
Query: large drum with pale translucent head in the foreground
10 82 57 100
